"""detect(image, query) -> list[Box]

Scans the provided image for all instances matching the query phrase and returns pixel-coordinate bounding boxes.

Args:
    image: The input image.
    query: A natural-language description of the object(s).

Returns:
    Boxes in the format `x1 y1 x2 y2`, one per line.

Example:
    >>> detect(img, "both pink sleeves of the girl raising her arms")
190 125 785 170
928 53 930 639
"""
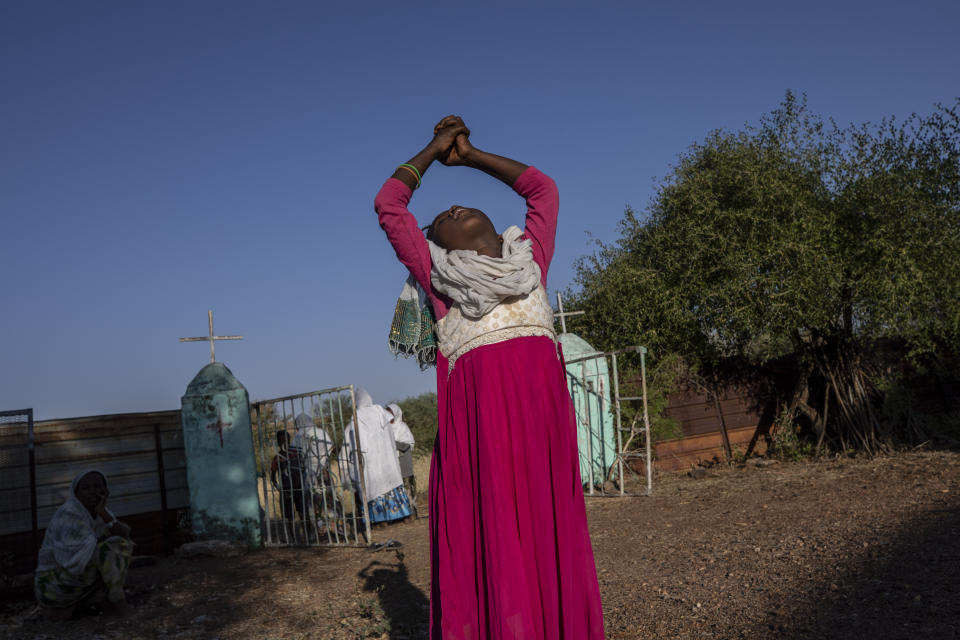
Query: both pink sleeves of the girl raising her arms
373 167 560 320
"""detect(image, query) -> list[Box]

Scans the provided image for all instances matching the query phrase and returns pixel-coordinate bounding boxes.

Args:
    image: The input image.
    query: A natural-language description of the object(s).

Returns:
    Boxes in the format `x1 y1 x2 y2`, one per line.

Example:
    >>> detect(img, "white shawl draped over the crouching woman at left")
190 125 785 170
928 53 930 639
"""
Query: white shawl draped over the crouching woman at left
37 469 116 575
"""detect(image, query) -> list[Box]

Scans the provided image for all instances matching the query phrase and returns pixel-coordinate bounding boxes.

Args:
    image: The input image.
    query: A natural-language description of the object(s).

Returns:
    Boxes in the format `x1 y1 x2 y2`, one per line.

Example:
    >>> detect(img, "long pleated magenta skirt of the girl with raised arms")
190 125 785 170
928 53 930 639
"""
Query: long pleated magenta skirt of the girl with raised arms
430 337 603 640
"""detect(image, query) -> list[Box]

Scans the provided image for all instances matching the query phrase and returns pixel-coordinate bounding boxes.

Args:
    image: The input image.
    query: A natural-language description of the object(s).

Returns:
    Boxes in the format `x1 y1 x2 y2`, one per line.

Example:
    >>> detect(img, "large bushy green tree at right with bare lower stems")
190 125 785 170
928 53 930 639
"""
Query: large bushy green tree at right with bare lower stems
571 92 960 451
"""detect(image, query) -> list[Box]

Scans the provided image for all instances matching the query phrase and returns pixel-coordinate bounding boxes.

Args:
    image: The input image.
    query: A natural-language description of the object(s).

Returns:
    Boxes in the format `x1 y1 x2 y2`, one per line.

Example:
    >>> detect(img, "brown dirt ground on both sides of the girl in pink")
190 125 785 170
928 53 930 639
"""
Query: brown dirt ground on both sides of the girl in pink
0 452 960 640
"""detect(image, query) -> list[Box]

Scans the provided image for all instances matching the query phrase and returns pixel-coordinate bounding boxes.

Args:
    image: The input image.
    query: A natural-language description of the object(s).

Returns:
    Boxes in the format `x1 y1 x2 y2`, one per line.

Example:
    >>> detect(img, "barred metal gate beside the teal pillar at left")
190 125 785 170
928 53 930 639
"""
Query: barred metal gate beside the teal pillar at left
250 385 372 546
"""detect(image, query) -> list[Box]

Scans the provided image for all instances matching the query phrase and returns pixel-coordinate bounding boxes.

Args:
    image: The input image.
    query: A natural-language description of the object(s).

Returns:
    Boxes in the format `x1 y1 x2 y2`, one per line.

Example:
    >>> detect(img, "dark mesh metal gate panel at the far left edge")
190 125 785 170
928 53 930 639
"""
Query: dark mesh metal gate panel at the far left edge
0 409 40 580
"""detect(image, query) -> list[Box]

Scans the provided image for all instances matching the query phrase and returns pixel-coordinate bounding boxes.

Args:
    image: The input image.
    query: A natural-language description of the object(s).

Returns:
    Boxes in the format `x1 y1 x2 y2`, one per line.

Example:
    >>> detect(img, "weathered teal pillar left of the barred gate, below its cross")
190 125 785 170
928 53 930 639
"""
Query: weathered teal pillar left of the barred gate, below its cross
180 362 262 547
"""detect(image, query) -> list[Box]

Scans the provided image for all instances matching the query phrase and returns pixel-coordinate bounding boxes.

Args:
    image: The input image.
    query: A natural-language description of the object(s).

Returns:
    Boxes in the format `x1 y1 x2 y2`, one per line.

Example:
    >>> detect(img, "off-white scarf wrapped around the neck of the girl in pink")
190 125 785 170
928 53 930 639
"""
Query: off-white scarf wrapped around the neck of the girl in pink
427 225 540 319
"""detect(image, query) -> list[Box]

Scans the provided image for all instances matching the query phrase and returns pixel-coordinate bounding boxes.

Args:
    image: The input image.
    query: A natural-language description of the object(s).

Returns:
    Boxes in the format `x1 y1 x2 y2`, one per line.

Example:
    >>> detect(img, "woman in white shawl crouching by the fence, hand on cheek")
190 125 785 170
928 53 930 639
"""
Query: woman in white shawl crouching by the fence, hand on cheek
33 470 133 620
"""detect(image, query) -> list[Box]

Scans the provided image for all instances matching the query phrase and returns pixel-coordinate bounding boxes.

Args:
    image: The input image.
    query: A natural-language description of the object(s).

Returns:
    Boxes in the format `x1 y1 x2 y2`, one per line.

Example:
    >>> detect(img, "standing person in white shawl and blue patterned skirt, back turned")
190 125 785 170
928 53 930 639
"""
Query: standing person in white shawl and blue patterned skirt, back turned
344 388 410 522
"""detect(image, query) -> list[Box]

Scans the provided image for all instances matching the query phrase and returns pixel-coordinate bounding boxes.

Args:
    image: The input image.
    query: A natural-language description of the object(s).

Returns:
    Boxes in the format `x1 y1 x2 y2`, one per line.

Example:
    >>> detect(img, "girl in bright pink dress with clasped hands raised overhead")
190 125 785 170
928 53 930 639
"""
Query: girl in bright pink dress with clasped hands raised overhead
374 116 603 640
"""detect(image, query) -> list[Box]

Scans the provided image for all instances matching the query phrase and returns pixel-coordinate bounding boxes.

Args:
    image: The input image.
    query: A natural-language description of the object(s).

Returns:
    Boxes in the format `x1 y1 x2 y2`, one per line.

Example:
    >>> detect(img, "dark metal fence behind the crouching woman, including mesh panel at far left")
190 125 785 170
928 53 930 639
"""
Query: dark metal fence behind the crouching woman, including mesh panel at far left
0 411 189 576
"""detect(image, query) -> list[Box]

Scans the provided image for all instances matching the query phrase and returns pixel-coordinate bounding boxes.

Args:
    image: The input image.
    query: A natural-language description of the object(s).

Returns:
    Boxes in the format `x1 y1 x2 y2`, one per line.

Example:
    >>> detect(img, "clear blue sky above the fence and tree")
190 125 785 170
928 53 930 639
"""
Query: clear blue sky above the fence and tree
0 0 960 419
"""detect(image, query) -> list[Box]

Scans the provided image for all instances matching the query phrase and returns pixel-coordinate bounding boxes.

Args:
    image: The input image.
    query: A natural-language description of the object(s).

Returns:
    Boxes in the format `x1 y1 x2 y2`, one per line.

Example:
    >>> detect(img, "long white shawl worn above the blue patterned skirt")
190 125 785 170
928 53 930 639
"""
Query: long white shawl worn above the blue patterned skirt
344 387 403 501
